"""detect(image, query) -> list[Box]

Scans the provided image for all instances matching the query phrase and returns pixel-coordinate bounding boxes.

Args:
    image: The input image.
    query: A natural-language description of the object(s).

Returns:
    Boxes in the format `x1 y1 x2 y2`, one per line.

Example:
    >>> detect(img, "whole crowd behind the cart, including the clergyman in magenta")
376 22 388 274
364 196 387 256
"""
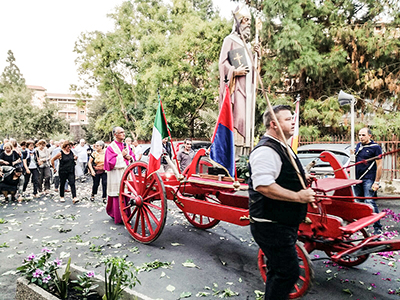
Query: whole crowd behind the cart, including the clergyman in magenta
0 131 194 230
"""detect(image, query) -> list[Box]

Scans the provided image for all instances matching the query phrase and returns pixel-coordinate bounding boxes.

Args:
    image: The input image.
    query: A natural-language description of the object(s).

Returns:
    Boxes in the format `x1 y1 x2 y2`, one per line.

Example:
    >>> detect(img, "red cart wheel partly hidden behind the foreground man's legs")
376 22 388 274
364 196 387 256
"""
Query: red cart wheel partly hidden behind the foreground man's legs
258 242 314 299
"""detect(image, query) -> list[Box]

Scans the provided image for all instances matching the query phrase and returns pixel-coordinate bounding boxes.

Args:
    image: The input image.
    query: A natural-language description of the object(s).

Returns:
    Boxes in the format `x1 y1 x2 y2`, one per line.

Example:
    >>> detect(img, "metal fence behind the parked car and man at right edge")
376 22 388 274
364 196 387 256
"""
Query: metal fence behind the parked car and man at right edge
299 136 400 181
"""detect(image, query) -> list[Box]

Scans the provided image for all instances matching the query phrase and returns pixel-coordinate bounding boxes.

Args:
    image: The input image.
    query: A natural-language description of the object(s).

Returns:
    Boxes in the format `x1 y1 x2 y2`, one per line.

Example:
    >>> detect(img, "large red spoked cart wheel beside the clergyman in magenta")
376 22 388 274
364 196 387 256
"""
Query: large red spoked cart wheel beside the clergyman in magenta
119 161 167 244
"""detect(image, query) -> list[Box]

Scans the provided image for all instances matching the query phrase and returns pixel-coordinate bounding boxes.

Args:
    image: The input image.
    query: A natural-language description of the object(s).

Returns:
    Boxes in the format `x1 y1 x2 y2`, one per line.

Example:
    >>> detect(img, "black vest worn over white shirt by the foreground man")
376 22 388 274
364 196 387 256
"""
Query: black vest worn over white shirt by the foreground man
249 136 307 226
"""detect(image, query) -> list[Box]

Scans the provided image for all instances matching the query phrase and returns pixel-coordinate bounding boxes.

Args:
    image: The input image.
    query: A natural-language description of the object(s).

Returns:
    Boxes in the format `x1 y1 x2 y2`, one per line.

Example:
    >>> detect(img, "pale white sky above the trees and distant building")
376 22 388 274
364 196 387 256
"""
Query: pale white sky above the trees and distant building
0 0 237 93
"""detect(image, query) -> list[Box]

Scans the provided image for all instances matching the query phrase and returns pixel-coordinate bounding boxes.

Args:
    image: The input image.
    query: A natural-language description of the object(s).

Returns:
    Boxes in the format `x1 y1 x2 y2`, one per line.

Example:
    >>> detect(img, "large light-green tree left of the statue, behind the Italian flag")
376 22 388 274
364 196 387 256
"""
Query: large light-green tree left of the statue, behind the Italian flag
75 0 230 139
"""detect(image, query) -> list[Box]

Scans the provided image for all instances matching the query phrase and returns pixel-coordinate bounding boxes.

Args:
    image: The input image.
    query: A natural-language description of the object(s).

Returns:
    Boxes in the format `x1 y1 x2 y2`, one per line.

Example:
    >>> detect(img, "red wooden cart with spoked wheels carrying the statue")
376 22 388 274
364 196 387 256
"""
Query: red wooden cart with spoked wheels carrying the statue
119 149 400 299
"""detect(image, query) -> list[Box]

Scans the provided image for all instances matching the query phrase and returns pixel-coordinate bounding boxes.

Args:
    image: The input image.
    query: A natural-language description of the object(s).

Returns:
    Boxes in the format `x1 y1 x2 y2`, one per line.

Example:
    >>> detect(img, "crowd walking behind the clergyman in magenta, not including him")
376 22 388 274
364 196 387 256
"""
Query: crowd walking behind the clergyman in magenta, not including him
0 138 142 204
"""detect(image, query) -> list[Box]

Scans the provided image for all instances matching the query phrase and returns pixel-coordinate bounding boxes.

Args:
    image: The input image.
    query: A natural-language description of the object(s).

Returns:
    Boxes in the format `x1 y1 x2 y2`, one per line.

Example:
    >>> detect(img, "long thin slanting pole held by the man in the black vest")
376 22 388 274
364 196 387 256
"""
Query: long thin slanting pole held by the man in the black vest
232 11 307 189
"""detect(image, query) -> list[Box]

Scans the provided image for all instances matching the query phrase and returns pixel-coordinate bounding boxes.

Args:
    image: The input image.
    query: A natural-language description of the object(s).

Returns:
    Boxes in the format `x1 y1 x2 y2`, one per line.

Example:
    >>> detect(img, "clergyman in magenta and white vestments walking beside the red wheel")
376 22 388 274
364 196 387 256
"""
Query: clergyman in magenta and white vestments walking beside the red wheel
104 127 135 224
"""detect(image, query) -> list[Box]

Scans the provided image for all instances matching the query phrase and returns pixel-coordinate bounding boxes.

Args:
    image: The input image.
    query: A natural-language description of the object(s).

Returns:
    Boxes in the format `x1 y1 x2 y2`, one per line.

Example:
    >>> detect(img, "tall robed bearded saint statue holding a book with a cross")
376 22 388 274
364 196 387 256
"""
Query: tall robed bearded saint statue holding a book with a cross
219 5 259 156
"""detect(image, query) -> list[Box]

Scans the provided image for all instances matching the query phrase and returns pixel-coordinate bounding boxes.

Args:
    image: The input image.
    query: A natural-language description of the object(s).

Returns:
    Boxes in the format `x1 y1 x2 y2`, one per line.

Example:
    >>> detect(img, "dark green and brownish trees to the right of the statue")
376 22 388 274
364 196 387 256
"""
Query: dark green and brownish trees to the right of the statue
247 0 400 139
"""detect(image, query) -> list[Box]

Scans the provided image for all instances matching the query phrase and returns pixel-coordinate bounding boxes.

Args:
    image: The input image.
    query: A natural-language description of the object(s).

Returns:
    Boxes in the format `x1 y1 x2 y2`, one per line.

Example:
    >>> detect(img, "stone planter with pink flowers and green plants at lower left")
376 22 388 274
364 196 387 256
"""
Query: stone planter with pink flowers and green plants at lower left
15 248 147 300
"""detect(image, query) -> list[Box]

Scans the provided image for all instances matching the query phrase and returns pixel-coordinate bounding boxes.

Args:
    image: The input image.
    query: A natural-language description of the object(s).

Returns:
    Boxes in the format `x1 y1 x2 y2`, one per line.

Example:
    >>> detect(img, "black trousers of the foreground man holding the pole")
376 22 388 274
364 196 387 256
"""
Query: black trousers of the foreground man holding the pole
250 222 300 300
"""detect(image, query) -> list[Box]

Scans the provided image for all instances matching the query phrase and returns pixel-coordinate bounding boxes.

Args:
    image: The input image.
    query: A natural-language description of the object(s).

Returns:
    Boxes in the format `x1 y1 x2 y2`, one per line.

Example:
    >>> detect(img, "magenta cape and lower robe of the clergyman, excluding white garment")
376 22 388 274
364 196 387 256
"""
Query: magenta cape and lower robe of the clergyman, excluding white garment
104 141 136 224
